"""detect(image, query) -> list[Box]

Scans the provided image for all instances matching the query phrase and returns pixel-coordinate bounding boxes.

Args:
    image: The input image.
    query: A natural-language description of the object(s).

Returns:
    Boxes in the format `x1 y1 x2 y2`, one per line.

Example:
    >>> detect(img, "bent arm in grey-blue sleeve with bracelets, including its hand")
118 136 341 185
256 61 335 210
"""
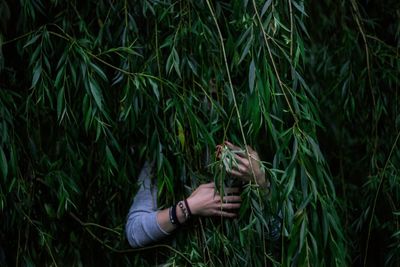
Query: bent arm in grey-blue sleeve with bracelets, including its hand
125 163 241 247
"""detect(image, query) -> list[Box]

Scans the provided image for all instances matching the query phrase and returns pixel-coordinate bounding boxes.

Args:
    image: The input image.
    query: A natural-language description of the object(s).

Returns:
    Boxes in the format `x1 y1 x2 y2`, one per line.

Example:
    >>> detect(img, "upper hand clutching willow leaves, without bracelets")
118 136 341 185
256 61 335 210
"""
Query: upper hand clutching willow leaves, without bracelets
217 141 268 187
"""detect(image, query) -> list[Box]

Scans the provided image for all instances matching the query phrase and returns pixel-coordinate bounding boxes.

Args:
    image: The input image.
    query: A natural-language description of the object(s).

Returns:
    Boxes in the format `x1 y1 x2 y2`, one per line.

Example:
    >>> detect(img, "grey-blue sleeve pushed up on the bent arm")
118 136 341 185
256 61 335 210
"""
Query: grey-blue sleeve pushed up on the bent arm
125 162 169 248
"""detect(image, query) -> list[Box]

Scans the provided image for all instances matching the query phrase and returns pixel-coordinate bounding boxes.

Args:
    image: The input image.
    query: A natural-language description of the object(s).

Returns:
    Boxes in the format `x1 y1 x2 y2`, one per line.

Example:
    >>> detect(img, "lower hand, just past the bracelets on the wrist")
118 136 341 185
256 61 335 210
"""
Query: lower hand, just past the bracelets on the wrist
187 183 242 218
